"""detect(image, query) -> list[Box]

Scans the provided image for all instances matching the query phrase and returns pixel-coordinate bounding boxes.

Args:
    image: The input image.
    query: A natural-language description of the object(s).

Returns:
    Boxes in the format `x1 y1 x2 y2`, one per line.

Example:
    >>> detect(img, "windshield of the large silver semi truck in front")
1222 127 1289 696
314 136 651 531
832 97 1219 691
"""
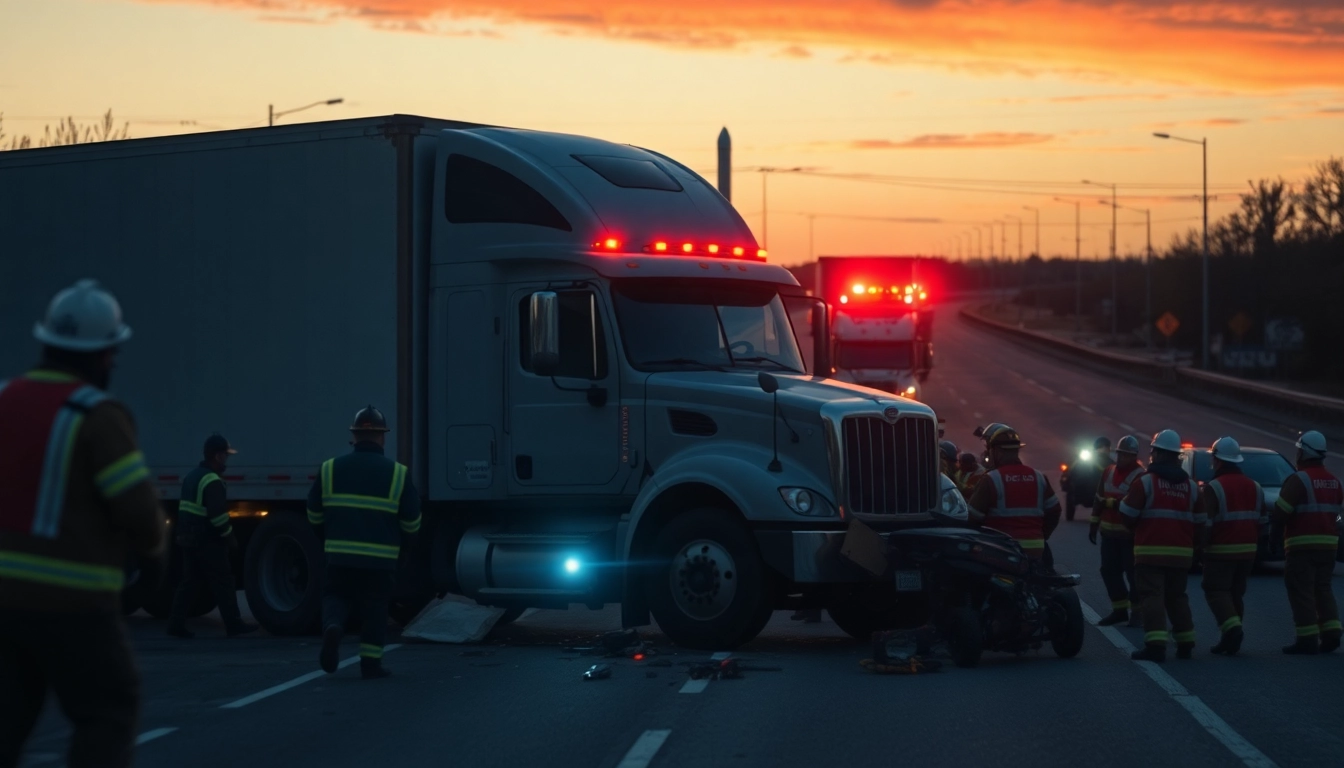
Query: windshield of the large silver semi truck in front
613 280 802 373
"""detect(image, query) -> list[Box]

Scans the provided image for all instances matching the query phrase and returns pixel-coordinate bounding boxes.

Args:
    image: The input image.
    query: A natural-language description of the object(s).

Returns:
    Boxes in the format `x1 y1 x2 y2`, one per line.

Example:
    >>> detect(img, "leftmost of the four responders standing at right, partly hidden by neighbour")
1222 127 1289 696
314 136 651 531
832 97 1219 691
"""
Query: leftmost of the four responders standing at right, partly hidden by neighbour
1087 434 1144 627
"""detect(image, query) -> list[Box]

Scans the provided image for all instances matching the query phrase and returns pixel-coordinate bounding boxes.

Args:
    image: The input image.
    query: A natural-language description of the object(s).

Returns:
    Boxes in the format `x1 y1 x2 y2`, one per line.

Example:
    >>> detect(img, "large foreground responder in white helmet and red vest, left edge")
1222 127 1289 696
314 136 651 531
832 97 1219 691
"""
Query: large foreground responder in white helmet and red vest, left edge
0 280 167 768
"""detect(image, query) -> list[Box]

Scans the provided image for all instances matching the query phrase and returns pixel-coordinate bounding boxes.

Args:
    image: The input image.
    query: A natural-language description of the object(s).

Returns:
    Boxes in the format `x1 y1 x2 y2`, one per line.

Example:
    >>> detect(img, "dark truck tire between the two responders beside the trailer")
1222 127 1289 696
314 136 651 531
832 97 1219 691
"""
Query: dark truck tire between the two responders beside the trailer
243 511 327 635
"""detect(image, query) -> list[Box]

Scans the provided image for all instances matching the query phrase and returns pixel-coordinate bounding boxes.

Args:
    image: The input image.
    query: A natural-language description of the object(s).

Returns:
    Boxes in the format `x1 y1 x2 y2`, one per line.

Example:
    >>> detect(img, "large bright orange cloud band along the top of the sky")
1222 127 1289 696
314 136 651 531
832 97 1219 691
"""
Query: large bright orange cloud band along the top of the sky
144 0 1344 91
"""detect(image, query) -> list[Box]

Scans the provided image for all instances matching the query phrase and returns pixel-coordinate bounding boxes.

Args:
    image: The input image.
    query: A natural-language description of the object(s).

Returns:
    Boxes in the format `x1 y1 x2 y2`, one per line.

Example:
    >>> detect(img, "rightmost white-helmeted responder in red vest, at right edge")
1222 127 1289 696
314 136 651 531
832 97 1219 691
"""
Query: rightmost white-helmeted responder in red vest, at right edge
1274 430 1344 655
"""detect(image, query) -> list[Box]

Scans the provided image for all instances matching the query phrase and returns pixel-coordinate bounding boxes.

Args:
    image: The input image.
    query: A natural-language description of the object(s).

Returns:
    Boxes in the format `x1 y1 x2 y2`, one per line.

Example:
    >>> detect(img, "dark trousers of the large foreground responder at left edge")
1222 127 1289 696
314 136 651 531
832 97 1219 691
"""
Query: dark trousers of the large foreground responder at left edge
0 608 140 768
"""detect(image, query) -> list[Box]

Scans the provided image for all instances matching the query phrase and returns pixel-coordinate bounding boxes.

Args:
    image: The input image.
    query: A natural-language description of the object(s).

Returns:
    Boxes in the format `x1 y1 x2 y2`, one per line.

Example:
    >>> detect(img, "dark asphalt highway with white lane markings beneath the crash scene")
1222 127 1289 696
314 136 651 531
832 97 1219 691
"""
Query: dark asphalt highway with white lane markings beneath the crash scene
13 312 1344 768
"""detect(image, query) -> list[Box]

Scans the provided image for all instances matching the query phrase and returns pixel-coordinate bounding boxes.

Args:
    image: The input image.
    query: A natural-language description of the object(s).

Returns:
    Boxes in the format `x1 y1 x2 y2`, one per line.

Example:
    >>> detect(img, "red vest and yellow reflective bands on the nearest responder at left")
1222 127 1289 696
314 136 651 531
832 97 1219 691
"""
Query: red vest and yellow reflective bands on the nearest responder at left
0 370 128 593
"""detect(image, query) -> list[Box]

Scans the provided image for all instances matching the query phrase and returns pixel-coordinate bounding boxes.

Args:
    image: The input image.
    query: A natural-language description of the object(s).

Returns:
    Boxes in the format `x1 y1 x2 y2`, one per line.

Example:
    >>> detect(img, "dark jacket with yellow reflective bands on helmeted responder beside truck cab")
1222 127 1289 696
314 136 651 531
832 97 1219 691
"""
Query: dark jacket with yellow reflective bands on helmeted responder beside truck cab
308 441 421 570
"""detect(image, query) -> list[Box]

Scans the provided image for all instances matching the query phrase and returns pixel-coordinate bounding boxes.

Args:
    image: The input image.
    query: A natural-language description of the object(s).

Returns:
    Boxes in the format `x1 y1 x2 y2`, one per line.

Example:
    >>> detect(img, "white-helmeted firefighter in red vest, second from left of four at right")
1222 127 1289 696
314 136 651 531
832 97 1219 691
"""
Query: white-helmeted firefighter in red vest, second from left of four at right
1120 429 1204 662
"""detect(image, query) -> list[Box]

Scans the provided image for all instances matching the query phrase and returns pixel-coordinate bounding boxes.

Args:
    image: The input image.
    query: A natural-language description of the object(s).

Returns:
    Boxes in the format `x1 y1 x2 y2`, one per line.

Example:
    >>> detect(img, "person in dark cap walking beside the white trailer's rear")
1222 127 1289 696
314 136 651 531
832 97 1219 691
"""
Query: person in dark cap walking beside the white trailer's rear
168 433 257 639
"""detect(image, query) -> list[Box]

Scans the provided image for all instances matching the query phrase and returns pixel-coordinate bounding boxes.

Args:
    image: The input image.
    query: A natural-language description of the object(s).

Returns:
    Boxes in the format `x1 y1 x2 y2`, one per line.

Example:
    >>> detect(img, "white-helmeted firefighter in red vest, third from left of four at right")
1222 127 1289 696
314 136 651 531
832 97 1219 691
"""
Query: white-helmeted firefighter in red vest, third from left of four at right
1200 437 1269 656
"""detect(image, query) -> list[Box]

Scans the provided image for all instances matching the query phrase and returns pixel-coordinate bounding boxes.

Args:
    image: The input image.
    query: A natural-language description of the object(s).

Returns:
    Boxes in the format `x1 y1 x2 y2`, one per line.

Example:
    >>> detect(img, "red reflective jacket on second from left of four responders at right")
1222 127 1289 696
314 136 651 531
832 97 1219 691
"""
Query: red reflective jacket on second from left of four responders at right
1120 467 1207 568
